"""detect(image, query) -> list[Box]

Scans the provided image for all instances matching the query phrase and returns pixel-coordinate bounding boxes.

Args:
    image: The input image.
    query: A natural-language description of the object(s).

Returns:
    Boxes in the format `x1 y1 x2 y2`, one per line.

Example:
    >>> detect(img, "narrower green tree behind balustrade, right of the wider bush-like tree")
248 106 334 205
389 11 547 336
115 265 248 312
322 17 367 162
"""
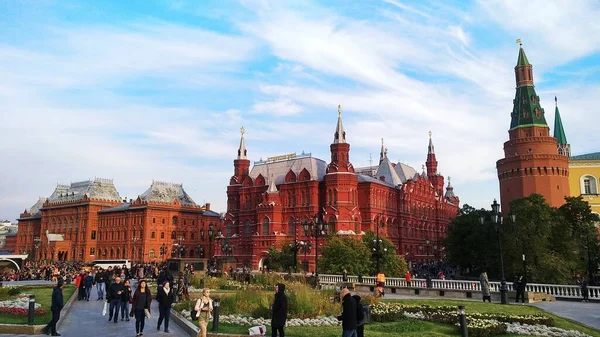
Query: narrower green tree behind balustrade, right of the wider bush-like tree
362 232 408 277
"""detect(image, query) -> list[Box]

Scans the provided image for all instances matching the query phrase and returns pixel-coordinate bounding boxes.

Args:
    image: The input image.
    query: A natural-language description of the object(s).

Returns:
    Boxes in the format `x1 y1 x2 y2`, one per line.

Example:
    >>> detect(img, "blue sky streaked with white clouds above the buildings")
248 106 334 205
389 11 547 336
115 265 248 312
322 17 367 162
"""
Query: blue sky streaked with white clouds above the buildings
0 0 600 220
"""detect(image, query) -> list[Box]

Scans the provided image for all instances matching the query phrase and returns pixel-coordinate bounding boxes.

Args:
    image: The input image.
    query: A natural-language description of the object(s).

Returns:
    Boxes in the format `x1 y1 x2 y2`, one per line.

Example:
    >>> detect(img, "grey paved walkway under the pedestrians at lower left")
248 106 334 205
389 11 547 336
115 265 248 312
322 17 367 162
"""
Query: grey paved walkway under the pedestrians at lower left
0 289 188 337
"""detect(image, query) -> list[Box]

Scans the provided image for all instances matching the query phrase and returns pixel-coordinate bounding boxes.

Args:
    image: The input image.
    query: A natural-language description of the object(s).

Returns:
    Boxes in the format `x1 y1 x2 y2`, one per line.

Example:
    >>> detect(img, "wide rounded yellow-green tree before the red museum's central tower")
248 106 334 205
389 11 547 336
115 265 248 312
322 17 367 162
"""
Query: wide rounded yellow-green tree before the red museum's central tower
319 235 371 275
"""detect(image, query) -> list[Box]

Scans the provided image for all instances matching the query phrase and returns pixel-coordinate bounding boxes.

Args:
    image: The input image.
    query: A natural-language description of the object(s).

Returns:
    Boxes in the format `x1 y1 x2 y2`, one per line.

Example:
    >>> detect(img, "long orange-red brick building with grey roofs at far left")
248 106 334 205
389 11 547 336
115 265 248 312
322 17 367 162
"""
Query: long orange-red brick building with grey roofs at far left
16 178 220 262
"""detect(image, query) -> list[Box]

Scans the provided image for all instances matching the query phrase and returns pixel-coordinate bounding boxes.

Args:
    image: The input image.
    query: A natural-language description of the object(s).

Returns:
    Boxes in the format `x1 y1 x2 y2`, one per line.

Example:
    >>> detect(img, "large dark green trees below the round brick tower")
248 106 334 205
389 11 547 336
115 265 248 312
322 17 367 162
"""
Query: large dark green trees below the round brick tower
445 194 600 283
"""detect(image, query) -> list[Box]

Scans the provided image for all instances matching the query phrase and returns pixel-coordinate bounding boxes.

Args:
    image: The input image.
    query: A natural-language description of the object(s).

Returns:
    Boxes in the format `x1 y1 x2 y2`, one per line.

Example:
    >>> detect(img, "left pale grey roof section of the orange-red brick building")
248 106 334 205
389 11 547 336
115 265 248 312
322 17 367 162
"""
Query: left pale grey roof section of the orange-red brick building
48 178 121 203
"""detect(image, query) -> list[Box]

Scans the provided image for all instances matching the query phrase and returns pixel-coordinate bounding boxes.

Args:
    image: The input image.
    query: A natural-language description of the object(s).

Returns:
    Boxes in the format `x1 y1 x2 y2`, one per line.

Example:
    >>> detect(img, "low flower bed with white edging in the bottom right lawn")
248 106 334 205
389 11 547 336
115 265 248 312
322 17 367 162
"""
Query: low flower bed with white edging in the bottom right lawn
371 303 587 337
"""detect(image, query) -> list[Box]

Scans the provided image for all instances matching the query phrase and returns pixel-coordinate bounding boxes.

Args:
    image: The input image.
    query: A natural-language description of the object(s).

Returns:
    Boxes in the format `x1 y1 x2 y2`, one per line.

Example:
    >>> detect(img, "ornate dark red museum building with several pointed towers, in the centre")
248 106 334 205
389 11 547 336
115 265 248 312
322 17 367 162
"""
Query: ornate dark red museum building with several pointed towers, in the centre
224 108 459 271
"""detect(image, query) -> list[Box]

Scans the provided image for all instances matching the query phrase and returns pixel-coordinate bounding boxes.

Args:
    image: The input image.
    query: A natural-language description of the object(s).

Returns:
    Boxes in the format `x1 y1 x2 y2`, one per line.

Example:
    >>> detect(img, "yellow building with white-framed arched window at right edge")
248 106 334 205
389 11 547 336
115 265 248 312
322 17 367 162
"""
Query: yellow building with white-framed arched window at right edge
569 152 600 214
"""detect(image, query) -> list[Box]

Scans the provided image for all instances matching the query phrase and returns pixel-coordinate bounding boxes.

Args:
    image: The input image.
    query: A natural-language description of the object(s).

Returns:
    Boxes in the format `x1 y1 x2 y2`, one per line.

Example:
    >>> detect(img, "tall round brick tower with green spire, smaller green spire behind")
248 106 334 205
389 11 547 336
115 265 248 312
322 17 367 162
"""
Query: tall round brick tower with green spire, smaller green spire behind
496 45 570 213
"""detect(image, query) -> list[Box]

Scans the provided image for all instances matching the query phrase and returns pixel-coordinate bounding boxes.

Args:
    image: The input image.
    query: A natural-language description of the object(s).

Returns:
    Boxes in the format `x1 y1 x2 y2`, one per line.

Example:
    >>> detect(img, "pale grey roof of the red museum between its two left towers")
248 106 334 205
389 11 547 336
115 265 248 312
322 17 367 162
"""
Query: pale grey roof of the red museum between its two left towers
250 154 327 185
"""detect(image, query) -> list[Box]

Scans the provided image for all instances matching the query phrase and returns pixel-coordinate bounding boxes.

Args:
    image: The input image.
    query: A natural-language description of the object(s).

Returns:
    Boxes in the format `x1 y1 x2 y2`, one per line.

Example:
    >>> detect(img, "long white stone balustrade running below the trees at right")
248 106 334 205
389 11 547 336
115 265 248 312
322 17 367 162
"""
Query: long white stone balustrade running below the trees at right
319 274 600 300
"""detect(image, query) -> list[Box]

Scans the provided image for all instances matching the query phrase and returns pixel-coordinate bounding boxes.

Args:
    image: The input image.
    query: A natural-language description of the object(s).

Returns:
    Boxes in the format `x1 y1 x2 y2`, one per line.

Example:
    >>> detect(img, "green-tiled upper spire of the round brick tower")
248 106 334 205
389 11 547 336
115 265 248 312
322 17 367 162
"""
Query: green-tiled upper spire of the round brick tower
510 39 548 130
